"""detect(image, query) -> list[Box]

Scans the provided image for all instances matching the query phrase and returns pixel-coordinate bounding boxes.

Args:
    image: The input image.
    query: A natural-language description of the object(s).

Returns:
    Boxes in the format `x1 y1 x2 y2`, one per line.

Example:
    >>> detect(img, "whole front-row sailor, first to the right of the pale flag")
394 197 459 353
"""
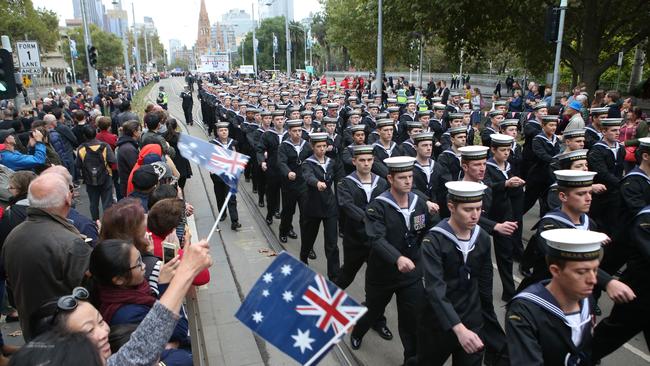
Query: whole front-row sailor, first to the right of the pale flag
257 110 287 225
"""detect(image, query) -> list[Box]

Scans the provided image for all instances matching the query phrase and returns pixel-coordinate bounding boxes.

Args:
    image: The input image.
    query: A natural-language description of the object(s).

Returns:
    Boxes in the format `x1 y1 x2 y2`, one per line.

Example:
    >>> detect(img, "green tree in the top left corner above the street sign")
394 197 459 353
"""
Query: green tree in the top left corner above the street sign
0 0 59 53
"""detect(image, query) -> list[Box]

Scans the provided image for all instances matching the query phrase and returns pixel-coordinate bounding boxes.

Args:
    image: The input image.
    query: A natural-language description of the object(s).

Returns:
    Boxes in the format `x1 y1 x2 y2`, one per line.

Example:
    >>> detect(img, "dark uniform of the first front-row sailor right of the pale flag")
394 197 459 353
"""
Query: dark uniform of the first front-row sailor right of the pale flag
257 129 288 221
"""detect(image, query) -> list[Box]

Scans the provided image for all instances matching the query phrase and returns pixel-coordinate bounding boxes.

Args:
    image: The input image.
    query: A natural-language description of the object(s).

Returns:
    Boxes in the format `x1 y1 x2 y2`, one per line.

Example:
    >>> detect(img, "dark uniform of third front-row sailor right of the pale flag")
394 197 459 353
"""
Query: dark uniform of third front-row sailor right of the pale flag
300 155 343 280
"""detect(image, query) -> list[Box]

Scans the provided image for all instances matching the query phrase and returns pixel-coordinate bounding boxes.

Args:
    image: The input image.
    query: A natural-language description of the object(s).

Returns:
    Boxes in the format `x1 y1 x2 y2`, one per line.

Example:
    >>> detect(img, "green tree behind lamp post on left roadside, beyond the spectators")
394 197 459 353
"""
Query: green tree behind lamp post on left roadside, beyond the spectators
63 24 124 78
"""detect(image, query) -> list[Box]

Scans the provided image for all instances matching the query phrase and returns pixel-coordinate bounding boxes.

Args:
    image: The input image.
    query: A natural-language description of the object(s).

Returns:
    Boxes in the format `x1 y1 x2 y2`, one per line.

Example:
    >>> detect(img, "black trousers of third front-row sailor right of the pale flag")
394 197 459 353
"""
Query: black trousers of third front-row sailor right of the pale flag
300 214 341 281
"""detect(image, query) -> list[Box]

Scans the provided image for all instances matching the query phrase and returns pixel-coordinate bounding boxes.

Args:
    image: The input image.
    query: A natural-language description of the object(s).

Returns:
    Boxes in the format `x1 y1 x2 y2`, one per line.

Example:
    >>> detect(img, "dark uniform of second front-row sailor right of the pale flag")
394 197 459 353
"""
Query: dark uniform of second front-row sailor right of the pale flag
278 139 312 236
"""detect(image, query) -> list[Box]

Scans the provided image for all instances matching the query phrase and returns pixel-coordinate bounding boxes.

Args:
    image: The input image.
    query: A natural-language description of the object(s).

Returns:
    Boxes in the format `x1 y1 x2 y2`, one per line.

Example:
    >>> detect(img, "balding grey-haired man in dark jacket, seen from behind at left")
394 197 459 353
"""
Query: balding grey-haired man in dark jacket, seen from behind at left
2 174 91 342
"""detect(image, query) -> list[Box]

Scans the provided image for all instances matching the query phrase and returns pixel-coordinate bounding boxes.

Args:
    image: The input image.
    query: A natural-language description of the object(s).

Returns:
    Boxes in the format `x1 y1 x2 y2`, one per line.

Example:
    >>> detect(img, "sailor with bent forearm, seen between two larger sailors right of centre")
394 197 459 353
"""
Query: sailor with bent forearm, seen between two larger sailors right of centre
486 134 526 302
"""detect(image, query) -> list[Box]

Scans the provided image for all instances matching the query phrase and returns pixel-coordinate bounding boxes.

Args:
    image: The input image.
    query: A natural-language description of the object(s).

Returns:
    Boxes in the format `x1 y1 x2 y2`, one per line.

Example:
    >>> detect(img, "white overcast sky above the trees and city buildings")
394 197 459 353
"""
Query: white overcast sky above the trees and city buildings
32 0 321 48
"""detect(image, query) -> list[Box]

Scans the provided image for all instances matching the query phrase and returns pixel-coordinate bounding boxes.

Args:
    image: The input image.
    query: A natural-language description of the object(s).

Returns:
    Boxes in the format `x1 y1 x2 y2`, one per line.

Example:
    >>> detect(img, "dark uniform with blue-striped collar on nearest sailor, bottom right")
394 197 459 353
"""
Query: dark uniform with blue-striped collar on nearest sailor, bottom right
506 280 594 366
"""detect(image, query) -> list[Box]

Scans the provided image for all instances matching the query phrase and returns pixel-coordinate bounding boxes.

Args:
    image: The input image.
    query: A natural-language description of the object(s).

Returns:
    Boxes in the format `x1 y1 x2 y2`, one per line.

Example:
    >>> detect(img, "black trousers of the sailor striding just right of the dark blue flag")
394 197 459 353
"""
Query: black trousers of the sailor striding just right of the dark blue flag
352 276 424 362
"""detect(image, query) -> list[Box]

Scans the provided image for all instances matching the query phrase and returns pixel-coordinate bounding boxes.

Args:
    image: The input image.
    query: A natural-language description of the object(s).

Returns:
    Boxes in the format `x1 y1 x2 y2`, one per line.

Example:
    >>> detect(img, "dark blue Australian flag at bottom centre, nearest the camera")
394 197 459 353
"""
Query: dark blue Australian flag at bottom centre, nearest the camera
235 252 367 365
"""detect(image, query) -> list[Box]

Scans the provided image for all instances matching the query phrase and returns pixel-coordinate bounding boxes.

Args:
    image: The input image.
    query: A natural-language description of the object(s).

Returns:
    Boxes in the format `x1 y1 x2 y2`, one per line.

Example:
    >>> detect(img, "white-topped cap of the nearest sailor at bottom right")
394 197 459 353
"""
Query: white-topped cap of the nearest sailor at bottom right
541 229 607 261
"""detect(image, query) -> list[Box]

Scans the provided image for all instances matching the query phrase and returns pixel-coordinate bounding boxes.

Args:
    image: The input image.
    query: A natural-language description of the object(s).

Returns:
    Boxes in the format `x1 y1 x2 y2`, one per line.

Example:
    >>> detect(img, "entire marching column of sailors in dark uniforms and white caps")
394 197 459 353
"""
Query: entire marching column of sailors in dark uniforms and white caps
194 79 650 365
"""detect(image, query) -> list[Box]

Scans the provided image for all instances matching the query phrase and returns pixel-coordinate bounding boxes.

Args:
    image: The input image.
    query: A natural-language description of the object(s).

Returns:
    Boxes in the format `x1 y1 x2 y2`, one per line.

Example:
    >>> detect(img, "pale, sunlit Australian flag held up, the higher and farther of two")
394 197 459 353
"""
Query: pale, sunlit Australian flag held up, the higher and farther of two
178 133 250 193
